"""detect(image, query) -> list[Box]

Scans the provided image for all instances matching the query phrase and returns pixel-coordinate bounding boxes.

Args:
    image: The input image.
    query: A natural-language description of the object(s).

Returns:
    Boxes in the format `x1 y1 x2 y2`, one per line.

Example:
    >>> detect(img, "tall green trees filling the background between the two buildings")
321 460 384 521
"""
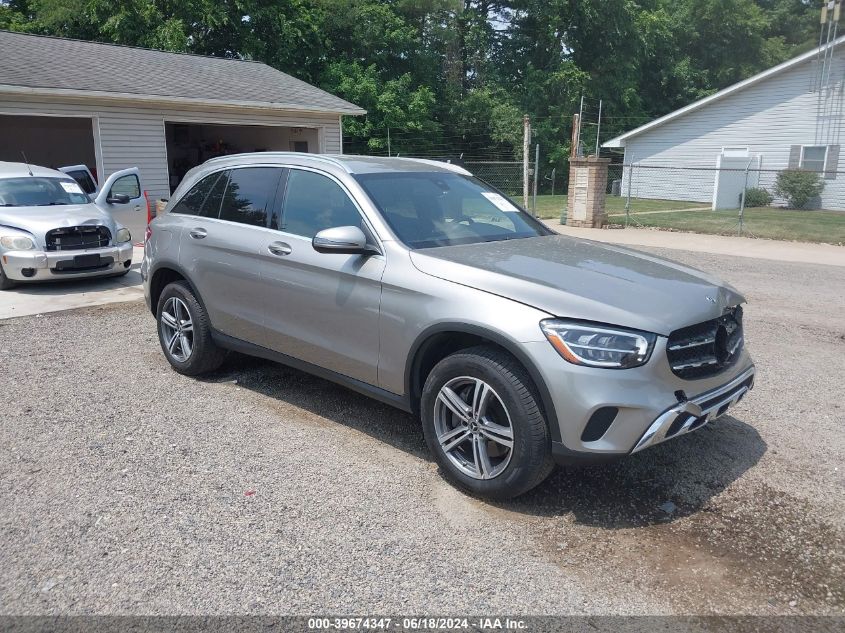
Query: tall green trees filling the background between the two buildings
0 0 819 173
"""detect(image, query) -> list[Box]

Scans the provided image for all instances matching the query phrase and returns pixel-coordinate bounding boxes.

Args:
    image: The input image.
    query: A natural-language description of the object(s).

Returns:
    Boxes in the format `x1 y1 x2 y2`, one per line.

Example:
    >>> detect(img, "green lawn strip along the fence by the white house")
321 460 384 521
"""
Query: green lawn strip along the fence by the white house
537 196 845 244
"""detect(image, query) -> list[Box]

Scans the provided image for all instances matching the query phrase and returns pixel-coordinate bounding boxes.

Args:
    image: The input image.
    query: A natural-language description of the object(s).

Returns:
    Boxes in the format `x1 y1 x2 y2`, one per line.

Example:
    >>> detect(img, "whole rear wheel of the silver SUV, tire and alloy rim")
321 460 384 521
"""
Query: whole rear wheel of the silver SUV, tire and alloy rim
156 281 226 376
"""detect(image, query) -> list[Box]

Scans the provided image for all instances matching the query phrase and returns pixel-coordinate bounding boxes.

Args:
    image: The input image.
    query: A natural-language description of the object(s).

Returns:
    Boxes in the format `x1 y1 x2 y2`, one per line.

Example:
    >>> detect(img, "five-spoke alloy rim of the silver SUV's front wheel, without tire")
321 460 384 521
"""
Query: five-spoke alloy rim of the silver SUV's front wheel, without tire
434 376 513 479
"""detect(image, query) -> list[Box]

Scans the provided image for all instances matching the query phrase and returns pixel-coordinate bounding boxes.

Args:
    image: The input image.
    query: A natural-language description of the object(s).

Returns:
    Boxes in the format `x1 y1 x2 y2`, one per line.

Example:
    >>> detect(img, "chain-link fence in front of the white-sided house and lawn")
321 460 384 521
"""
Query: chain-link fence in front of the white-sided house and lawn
552 159 845 244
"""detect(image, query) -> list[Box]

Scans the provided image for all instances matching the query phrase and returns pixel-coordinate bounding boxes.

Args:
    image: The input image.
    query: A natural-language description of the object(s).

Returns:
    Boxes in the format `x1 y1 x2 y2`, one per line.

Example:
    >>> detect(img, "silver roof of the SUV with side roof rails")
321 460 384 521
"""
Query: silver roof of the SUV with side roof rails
203 152 470 175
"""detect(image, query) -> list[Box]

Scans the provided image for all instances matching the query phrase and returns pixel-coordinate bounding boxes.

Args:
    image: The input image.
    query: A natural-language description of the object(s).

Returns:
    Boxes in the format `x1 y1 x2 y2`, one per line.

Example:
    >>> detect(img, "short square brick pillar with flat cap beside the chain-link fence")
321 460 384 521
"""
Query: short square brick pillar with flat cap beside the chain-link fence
566 156 610 228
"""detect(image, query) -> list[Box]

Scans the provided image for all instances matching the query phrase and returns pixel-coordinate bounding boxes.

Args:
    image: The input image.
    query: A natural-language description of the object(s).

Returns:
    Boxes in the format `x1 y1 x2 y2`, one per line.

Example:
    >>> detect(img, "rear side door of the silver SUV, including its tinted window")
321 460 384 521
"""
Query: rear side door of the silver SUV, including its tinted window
176 167 283 344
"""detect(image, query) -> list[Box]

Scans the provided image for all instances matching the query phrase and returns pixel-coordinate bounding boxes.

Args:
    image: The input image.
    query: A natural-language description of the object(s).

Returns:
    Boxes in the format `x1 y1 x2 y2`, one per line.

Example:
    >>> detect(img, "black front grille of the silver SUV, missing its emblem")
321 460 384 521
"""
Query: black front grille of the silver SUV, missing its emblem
666 306 743 380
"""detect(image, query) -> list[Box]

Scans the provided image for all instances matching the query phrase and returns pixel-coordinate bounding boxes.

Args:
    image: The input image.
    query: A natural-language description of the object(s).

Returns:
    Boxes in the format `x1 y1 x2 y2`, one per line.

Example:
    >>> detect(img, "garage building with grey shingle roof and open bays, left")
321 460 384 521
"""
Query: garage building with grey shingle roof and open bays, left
0 31 365 198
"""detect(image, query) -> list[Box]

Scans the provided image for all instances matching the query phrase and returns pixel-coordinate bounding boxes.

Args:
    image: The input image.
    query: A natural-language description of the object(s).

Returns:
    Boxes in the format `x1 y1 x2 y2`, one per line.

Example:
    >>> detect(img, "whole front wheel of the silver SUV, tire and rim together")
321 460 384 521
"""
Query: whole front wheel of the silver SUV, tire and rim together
420 346 553 499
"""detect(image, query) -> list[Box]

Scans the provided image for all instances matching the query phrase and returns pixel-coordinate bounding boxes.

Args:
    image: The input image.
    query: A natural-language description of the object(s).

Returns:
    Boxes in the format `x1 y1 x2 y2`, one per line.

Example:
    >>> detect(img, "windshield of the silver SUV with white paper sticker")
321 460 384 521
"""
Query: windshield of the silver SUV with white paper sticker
355 172 551 248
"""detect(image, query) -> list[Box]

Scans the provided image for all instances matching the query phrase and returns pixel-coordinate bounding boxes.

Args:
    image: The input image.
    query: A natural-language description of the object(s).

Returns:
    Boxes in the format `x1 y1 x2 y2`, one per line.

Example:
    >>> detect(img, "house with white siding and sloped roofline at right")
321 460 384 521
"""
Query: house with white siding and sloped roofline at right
603 37 845 209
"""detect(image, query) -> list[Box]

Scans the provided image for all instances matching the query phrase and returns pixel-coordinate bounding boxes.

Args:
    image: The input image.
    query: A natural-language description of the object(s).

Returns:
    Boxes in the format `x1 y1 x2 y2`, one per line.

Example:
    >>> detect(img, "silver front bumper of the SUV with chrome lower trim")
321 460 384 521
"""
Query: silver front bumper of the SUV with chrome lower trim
523 337 755 463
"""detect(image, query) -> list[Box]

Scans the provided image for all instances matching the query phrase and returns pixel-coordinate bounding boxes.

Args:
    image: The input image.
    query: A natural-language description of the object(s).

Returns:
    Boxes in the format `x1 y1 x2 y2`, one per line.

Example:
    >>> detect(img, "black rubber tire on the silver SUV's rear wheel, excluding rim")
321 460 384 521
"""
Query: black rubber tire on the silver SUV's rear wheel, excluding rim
156 281 226 376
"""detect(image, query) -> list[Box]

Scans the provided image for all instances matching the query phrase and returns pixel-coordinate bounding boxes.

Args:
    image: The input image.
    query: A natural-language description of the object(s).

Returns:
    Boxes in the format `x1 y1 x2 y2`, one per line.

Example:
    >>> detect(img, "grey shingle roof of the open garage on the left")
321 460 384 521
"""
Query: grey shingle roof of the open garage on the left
0 31 365 114
